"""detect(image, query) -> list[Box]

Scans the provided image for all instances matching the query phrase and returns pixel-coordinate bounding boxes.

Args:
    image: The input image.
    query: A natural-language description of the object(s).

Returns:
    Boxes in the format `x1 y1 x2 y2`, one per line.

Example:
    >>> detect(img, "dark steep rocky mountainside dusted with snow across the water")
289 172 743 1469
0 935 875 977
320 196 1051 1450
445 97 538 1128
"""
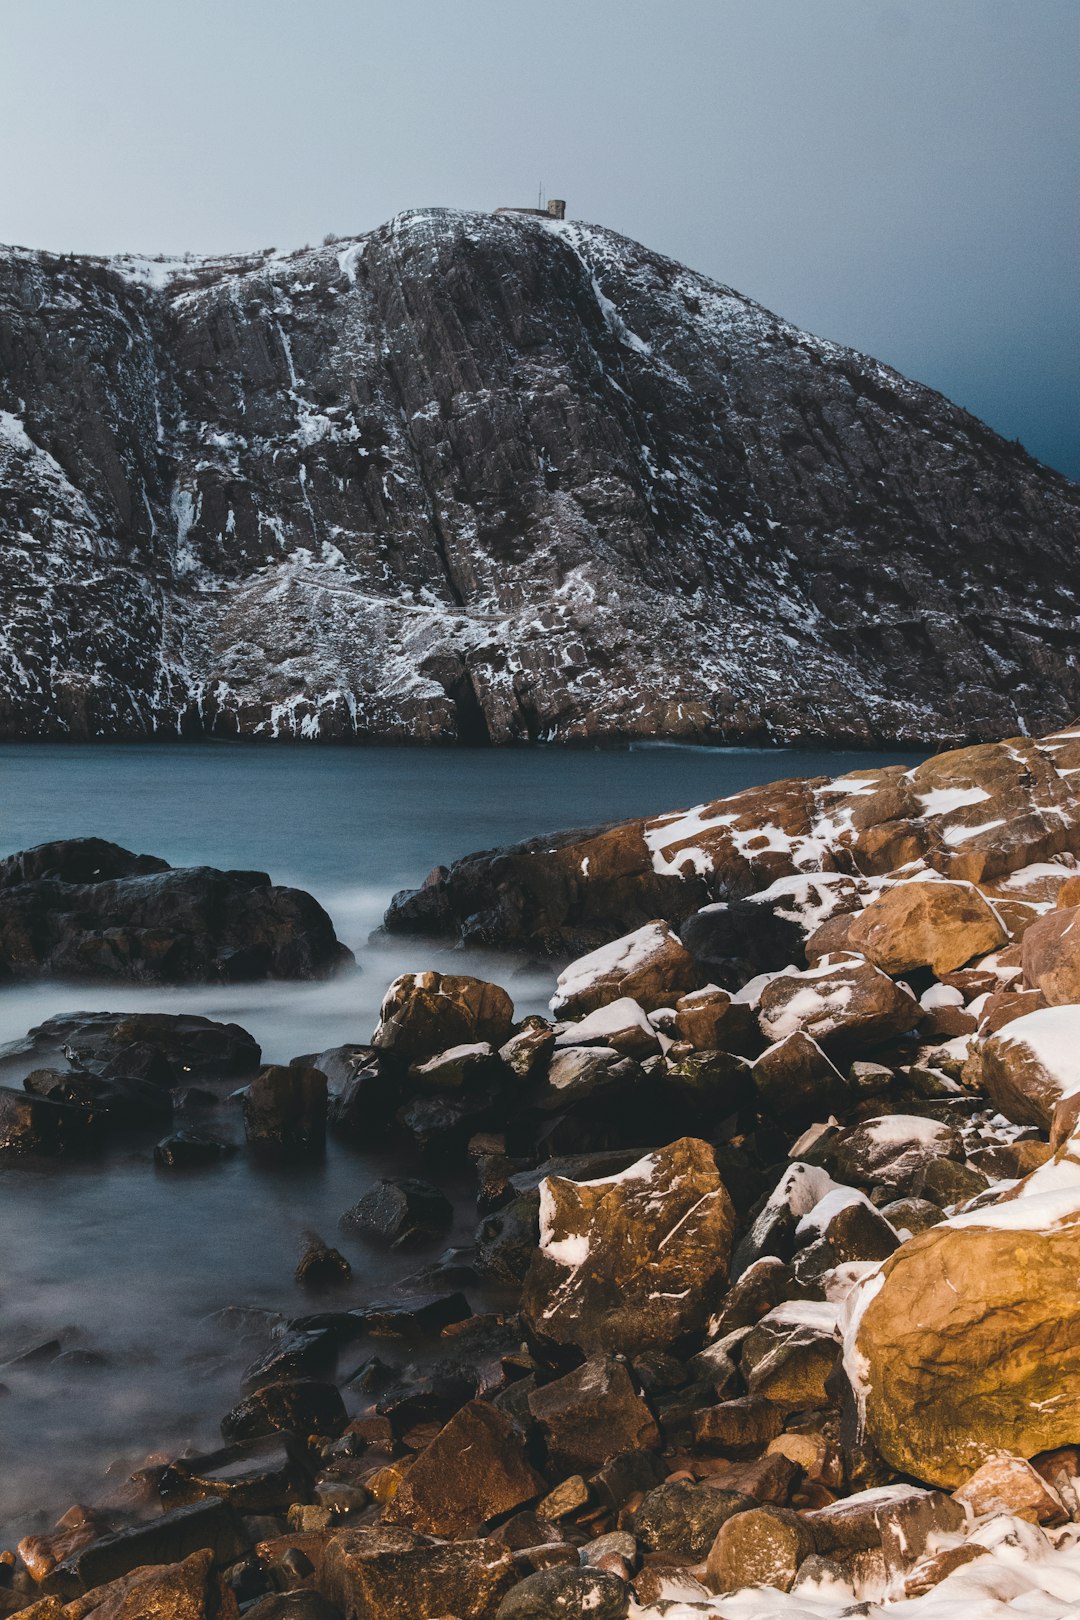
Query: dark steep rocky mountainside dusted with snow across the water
0 211 1080 742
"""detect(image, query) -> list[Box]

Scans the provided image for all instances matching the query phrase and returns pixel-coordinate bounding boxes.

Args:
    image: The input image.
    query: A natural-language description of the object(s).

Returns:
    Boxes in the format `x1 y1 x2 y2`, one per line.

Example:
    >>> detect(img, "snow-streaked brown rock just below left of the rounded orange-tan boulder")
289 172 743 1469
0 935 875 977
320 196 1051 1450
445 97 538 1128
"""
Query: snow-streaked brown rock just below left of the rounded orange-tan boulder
758 957 920 1053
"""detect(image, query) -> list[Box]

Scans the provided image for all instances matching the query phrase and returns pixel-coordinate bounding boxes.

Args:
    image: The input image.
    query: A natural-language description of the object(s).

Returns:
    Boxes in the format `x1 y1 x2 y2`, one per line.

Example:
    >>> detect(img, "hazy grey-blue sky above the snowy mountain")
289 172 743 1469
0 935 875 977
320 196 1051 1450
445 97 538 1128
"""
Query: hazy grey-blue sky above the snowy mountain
0 0 1080 476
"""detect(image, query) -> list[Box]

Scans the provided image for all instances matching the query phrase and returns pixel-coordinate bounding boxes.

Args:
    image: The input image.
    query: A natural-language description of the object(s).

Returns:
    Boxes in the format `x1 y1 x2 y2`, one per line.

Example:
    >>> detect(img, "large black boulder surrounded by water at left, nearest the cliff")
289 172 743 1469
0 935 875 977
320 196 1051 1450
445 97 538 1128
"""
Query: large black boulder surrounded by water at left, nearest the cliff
0 839 353 985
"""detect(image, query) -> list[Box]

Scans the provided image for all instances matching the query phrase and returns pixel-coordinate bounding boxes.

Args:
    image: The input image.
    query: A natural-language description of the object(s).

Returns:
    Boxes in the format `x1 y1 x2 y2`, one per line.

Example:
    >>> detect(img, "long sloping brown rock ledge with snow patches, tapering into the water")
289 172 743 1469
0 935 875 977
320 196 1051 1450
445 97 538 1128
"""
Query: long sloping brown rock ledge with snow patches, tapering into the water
385 727 1080 946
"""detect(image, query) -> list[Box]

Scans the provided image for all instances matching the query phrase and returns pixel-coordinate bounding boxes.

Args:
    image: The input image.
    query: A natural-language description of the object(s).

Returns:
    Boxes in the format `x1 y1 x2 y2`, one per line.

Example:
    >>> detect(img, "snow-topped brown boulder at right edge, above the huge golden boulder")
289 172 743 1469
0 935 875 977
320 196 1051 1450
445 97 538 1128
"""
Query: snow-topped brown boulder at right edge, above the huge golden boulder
965 1006 1080 1129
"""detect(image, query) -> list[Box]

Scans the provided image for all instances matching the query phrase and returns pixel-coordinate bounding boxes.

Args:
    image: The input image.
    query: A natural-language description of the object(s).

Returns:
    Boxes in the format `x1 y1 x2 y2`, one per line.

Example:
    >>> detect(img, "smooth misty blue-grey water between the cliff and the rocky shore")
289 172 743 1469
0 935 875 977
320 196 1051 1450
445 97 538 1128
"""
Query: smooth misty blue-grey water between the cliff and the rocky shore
0 744 919 1547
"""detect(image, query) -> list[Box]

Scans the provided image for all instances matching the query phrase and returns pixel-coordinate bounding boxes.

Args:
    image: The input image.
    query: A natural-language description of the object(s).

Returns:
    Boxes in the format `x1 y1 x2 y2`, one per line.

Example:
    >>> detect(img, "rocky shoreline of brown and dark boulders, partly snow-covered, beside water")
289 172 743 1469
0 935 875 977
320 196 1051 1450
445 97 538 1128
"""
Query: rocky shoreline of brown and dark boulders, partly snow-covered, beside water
0 727 1080 1620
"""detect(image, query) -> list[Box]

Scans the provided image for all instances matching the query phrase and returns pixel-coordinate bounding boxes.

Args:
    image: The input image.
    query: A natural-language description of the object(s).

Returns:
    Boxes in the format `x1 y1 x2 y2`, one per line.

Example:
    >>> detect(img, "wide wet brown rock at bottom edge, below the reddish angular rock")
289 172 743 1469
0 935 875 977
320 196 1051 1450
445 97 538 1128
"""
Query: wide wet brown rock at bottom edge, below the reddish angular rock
319 1526 517 1620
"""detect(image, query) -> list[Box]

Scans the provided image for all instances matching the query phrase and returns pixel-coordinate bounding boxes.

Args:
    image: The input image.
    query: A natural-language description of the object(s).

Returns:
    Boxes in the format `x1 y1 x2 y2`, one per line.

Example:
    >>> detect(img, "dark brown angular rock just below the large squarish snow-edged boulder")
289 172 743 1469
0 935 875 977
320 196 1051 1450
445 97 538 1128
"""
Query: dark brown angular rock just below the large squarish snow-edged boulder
528 1356 661 1474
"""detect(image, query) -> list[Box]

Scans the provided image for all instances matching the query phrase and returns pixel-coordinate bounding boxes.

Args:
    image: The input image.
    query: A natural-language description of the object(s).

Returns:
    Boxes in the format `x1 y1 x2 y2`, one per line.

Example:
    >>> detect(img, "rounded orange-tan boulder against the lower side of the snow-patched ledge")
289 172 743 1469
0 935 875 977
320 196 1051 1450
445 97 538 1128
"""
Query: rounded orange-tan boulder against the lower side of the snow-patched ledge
847 878 1009 974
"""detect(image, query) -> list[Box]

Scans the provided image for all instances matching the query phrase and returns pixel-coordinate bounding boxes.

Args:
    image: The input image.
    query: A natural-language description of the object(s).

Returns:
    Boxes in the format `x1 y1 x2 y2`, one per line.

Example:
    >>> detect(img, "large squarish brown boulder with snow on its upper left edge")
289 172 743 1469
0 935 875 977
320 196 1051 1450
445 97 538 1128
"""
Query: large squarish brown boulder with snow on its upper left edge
521 1137 735 1354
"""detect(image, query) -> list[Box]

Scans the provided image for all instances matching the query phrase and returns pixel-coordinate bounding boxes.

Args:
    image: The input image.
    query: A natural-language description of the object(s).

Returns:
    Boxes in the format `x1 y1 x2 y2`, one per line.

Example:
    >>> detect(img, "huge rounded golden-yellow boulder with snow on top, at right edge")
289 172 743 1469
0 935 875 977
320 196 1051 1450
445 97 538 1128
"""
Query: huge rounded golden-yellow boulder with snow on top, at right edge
844 1185 1080 1489
